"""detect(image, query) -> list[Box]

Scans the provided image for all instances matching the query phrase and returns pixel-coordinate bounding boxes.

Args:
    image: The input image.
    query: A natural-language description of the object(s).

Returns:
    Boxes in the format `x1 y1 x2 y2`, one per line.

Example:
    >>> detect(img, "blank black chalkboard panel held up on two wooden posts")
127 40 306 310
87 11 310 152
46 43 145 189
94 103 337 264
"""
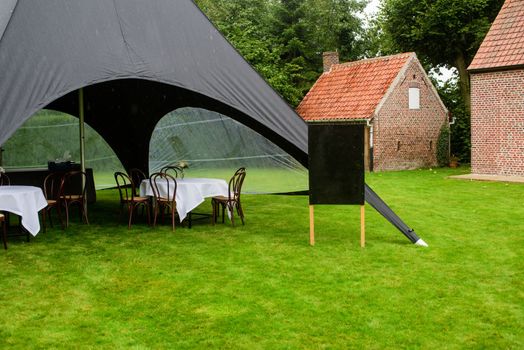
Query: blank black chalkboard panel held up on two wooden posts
308 123 365 205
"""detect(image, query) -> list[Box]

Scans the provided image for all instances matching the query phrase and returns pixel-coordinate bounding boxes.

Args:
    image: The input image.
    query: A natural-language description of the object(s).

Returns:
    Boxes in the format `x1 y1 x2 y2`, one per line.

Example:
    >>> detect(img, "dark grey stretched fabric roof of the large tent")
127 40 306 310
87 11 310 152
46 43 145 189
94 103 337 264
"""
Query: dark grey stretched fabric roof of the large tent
0 0 307 167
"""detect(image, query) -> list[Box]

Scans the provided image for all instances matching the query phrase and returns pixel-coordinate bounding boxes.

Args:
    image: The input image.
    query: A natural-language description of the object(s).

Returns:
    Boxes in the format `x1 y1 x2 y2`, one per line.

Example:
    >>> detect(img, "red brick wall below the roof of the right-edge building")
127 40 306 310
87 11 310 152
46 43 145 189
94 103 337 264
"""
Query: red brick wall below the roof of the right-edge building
471 69 524 176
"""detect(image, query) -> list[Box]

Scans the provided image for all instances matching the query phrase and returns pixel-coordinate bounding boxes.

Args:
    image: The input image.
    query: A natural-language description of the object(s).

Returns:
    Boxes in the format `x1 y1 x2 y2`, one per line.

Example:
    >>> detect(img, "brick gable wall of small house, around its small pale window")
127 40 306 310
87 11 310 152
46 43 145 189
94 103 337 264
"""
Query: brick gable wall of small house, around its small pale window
373 62 448 171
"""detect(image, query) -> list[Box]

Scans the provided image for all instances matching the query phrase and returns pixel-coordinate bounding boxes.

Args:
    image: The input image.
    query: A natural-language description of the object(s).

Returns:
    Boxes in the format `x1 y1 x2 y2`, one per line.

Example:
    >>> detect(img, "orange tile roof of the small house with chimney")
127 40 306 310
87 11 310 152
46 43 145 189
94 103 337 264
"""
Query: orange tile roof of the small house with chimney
297 52 416 121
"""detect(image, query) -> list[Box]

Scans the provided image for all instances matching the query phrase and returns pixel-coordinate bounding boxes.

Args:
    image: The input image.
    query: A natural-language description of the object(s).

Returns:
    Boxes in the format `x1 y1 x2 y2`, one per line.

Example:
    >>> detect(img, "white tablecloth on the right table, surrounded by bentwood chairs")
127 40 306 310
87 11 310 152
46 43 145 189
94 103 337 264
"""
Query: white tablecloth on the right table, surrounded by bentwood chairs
140 178 228 221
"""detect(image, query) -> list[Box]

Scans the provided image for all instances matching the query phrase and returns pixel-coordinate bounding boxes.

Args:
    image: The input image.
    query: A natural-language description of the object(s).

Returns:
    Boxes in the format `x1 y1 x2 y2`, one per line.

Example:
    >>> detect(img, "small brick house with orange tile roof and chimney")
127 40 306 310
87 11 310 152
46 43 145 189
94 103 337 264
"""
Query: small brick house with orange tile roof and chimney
297 52 448 171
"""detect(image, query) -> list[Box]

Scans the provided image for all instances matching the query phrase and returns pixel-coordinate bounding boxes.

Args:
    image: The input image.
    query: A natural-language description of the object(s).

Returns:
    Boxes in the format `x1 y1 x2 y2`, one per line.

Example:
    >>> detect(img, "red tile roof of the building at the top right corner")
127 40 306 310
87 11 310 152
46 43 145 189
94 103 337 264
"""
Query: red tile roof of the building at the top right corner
468 0 524 70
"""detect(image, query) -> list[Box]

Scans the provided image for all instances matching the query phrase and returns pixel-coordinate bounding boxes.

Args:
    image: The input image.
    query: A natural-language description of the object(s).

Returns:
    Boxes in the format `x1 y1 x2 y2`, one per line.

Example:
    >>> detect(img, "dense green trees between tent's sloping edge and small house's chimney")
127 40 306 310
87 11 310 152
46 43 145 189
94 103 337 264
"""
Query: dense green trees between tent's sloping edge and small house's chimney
196 0 367 106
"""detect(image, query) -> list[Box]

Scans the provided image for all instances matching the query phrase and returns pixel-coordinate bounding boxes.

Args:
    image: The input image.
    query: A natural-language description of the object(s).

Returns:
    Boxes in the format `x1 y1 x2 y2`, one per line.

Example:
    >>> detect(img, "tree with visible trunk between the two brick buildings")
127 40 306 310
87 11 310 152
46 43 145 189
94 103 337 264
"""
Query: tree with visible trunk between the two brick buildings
377 0 504 115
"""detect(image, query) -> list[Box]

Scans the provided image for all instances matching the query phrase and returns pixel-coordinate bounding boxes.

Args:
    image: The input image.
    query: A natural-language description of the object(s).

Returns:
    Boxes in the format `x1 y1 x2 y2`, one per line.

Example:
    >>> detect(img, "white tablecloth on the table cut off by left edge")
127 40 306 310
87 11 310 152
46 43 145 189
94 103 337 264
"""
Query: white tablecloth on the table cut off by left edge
0 186 47 236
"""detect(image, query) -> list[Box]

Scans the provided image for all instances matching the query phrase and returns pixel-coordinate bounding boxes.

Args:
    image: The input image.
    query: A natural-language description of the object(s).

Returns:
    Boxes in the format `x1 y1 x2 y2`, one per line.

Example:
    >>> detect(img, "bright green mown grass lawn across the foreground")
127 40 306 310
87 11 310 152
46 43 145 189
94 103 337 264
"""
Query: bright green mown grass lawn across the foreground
0 169 524 349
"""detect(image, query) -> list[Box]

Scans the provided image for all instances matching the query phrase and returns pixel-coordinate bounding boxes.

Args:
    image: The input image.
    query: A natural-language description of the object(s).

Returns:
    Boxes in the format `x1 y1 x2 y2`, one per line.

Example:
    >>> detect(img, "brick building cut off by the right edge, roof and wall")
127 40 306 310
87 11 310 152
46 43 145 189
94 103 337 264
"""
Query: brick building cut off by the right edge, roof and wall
468 0 524 176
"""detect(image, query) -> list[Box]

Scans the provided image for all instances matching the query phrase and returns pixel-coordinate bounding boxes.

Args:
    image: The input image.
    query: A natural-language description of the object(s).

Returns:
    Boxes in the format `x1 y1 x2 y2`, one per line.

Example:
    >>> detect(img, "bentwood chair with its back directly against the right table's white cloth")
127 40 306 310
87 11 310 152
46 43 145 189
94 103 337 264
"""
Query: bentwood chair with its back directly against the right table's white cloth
149 172 177 232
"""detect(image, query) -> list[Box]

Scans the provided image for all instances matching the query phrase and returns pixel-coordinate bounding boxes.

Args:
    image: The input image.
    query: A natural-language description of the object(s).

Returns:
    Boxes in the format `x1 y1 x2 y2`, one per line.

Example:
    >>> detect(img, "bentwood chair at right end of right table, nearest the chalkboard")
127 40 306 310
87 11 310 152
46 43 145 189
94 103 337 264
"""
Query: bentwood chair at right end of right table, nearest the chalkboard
211 168 246 226
